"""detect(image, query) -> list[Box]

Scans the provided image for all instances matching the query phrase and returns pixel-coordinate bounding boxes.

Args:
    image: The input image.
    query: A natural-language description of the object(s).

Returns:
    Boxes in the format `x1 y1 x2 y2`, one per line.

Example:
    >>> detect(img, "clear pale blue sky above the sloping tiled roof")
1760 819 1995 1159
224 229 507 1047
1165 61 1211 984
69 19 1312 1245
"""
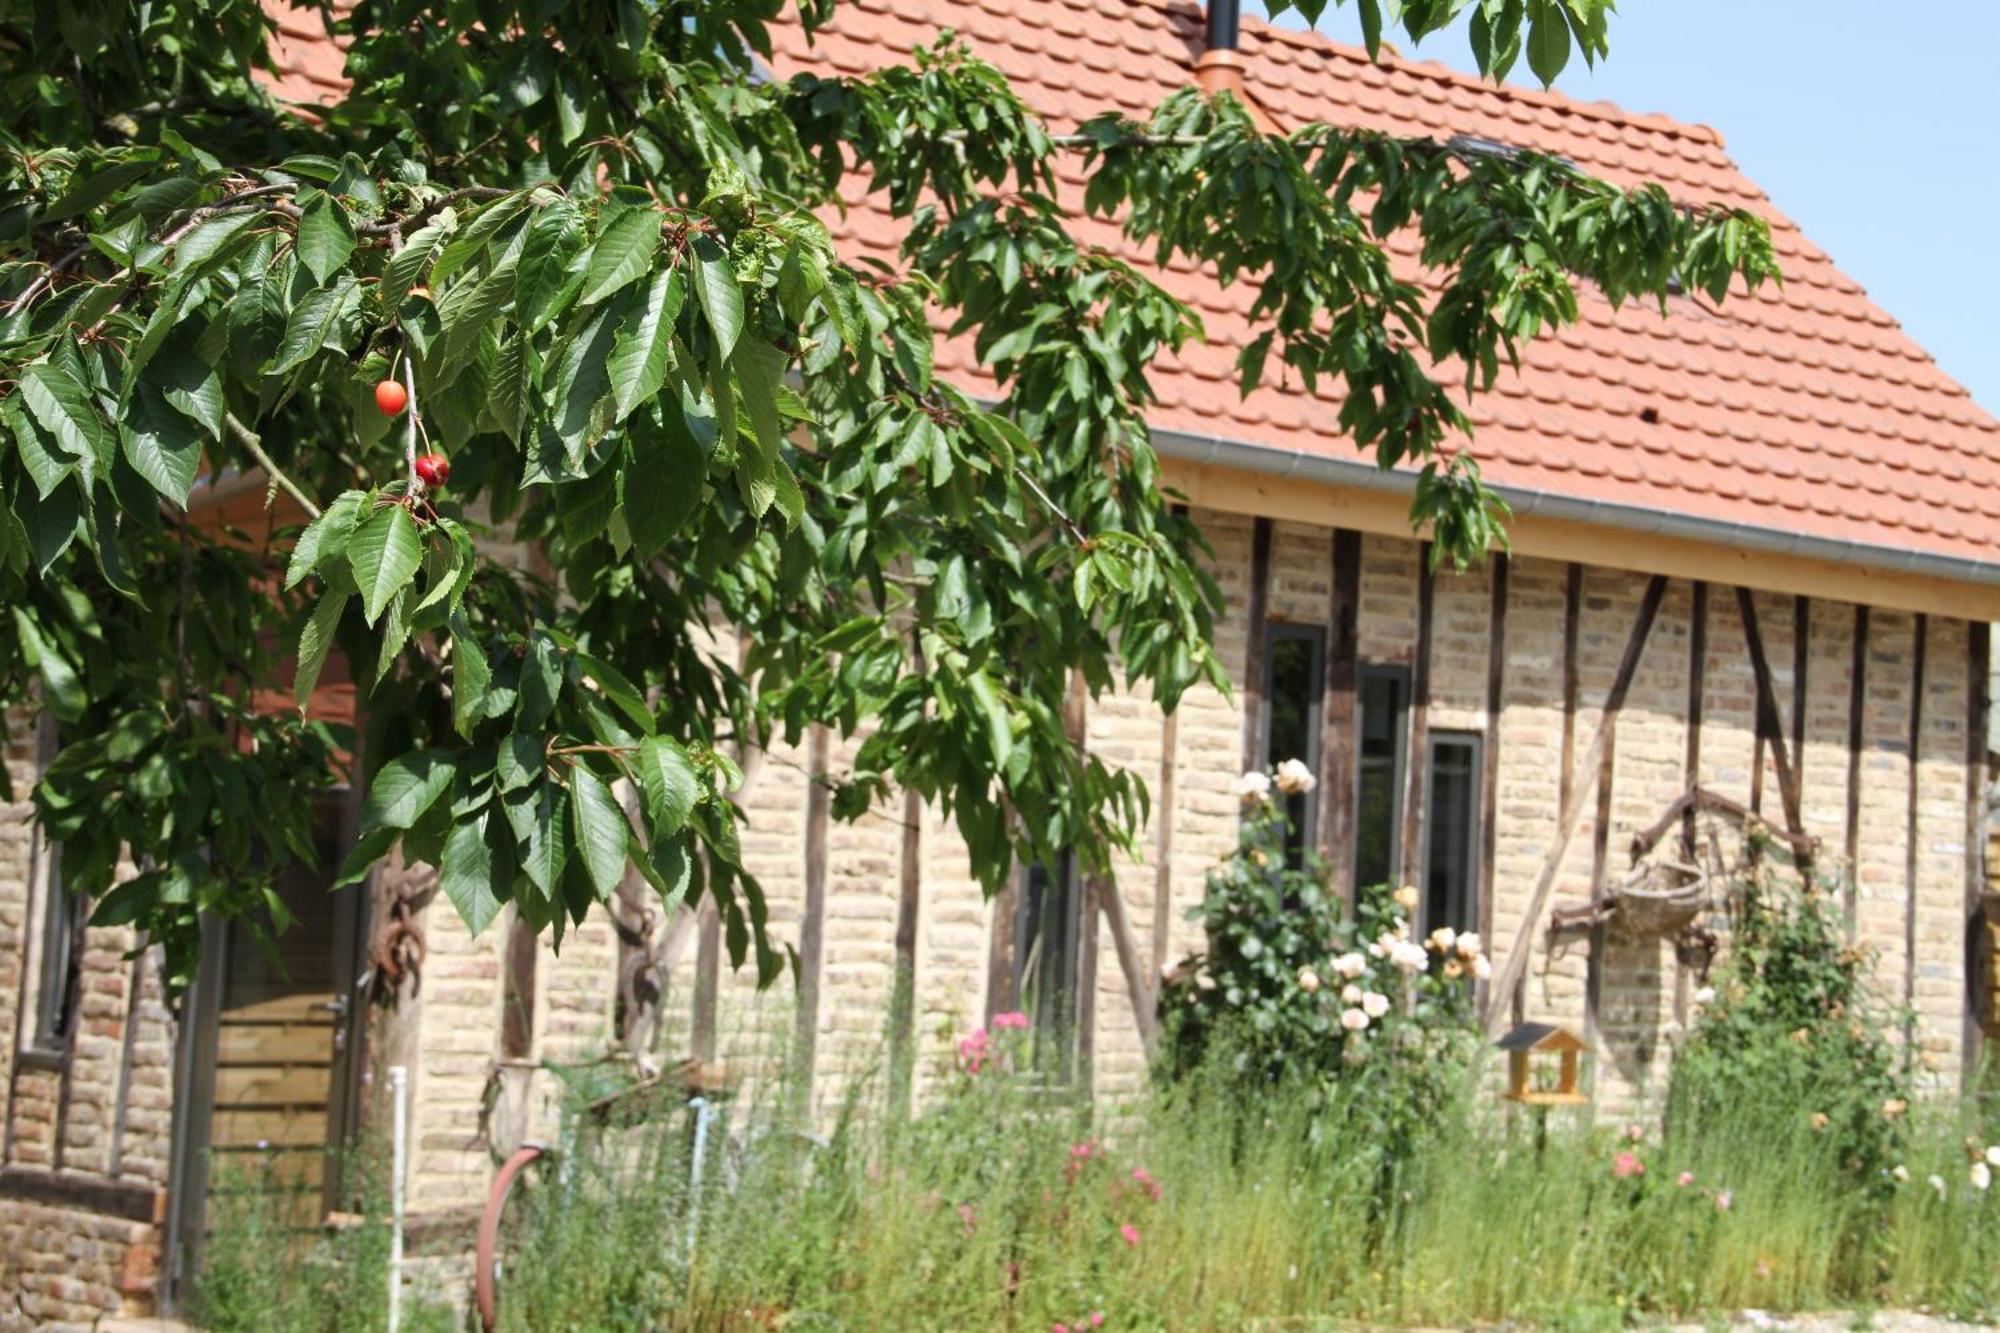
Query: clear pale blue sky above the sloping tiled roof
1244 0 2000 412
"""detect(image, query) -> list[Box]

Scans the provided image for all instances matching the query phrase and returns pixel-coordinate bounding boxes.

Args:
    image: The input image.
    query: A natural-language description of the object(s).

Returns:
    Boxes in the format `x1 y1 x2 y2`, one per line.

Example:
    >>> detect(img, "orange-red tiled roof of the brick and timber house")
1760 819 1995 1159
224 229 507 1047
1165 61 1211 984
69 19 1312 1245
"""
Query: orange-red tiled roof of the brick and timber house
266 0 2000 564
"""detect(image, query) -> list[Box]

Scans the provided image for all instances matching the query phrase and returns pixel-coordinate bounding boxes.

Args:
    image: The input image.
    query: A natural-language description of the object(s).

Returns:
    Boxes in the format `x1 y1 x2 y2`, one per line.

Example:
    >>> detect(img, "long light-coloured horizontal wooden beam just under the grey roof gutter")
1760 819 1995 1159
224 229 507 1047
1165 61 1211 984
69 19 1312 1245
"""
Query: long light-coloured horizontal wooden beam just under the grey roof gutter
1160 458 2000 620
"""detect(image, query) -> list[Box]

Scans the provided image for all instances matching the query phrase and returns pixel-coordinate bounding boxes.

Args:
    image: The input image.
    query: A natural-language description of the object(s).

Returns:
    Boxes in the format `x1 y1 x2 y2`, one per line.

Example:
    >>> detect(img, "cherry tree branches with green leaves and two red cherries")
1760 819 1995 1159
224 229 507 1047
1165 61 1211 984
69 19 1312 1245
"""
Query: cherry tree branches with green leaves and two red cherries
0 0 1774 983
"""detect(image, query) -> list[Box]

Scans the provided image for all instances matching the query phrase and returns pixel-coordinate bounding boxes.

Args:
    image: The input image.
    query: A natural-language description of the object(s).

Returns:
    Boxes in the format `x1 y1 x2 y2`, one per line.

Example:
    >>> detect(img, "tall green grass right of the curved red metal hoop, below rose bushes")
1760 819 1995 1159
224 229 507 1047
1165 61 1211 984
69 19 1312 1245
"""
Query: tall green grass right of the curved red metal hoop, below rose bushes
484 1048 2000 1331
